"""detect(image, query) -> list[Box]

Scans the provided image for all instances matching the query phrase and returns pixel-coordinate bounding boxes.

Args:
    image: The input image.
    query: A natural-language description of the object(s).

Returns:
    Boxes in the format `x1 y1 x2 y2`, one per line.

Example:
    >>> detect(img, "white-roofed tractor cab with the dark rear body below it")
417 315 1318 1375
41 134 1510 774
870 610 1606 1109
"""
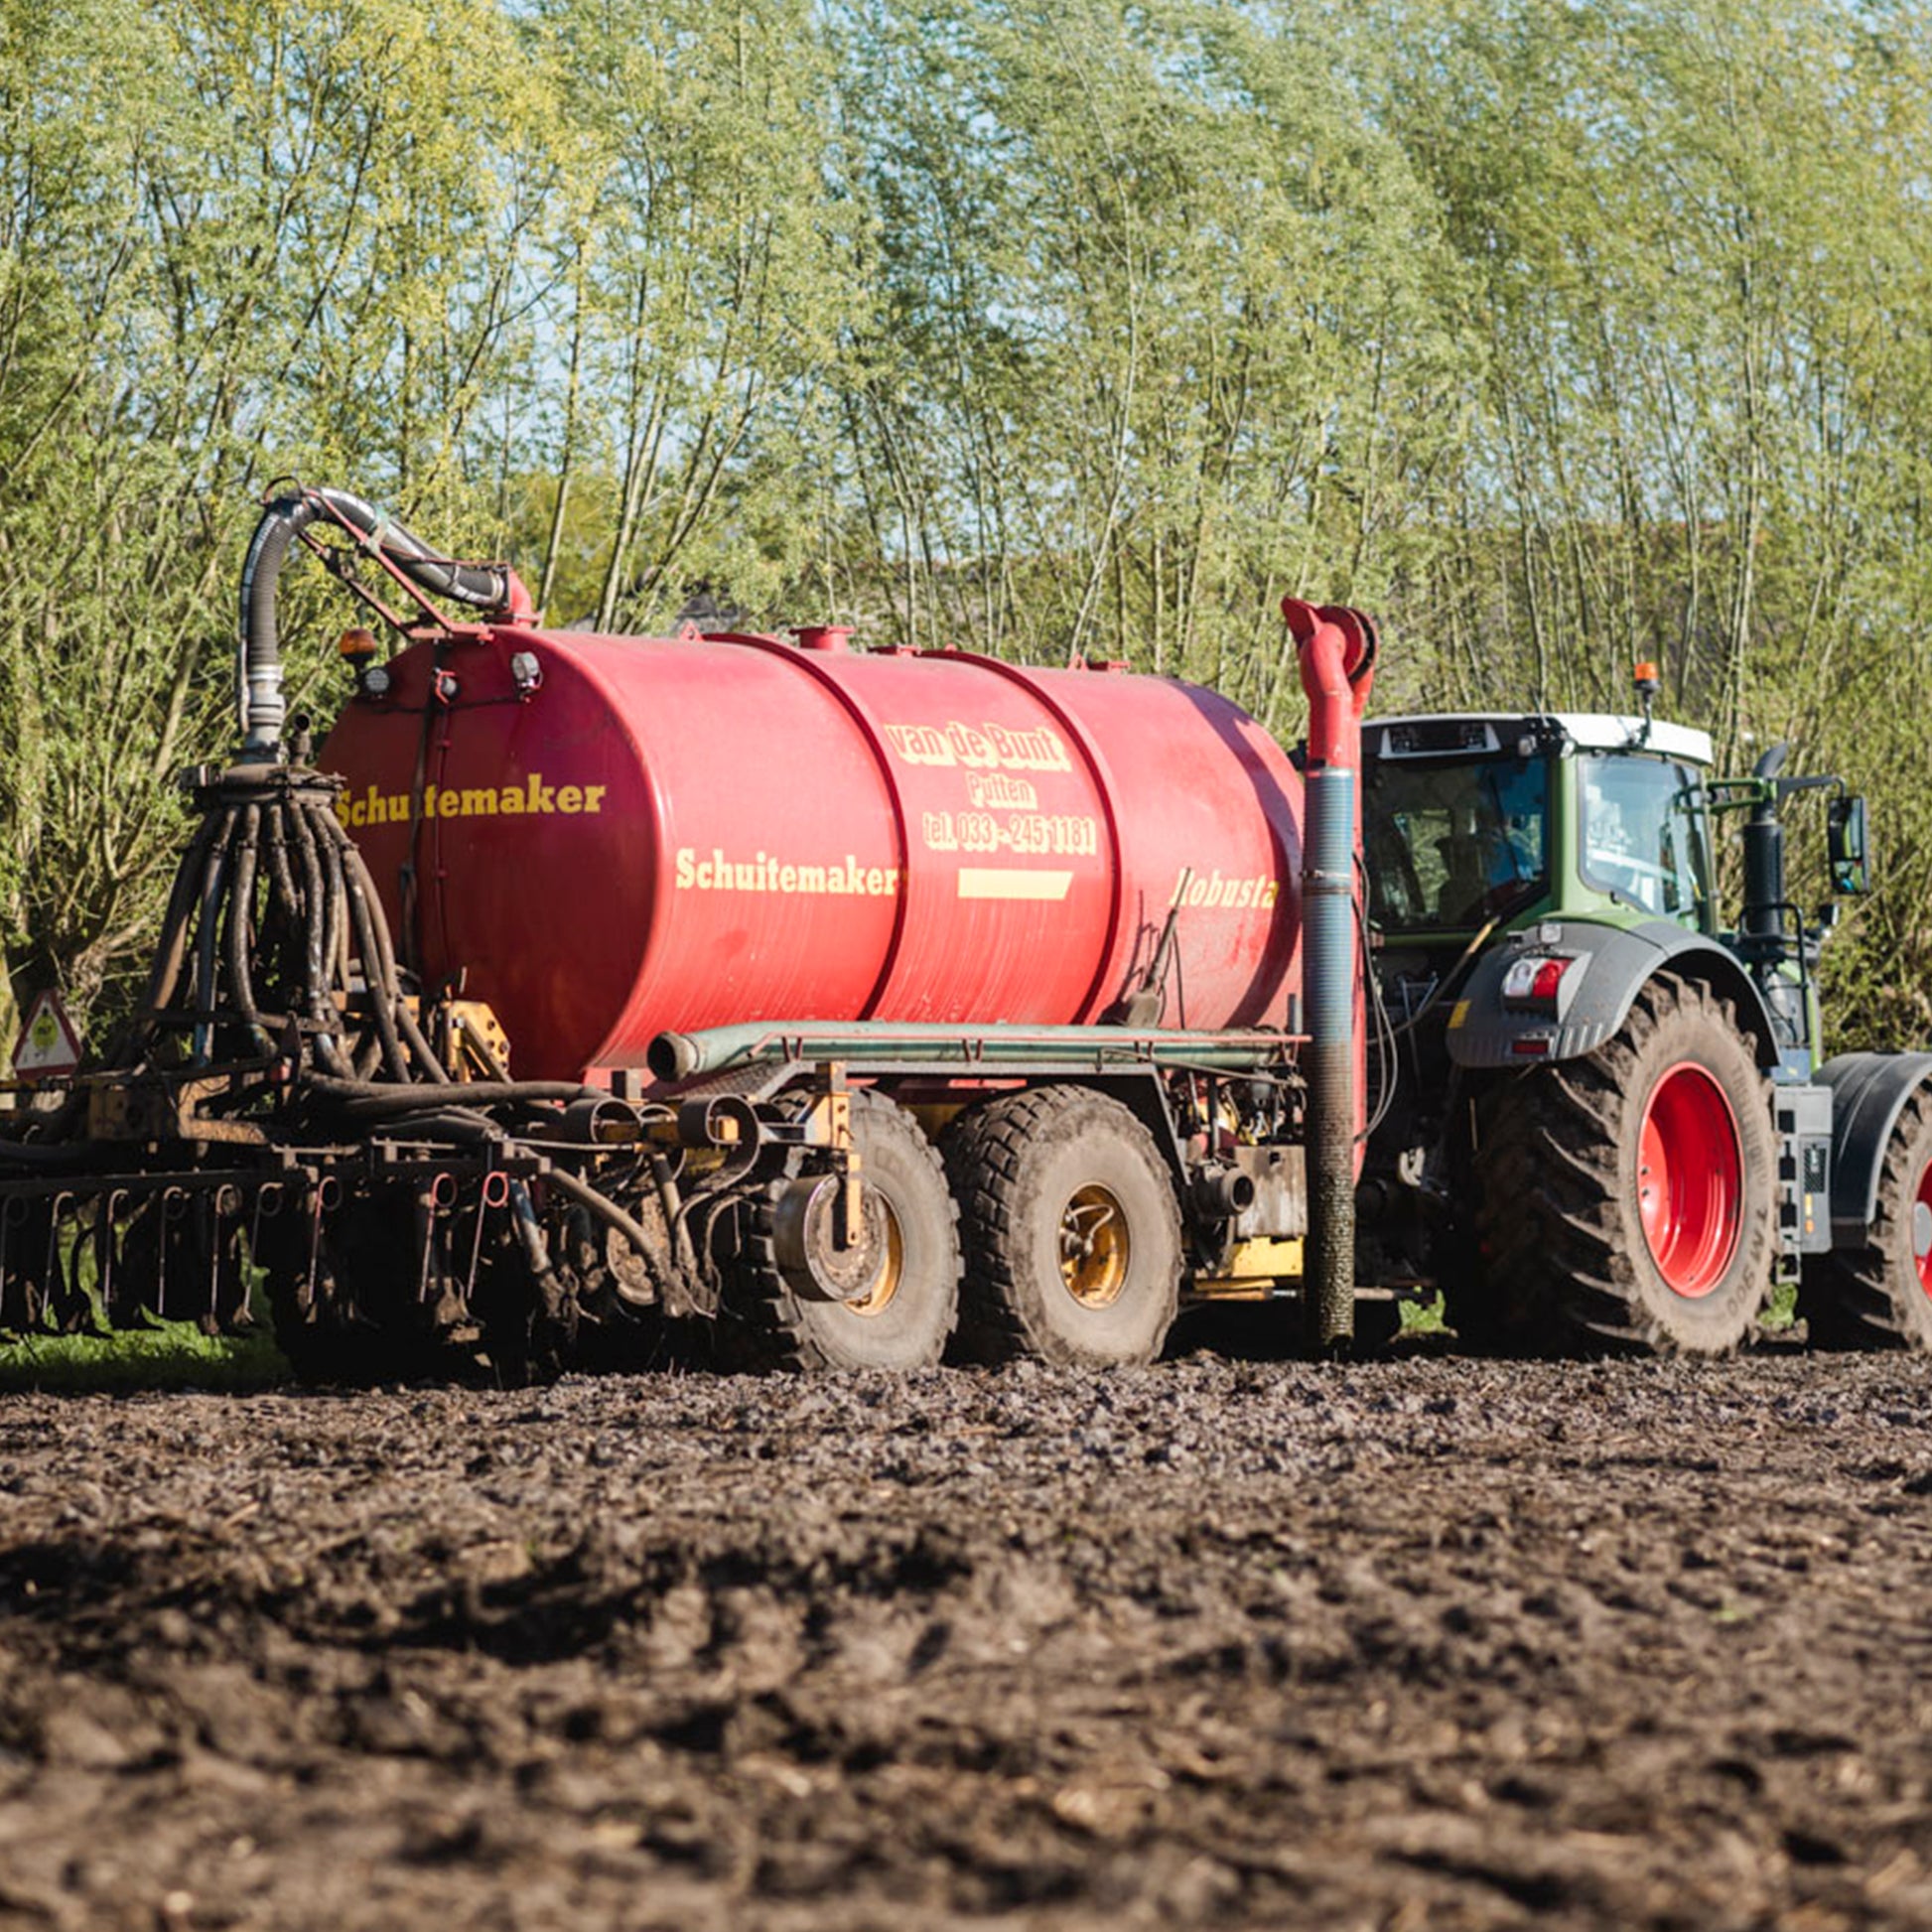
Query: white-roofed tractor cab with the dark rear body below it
1362 713 1716 1281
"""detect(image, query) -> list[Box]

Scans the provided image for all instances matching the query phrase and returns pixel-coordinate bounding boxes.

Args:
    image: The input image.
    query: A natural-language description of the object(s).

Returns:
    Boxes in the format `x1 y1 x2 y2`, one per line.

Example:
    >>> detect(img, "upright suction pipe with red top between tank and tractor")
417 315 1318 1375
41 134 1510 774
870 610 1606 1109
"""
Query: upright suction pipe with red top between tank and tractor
1281 597 1377 1348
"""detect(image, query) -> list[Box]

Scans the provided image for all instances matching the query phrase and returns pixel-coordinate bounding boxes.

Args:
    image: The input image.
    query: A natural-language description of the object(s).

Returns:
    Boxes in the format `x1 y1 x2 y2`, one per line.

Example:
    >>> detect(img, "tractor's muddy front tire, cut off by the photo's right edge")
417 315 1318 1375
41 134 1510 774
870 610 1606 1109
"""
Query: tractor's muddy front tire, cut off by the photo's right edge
1799 1091 1932 1348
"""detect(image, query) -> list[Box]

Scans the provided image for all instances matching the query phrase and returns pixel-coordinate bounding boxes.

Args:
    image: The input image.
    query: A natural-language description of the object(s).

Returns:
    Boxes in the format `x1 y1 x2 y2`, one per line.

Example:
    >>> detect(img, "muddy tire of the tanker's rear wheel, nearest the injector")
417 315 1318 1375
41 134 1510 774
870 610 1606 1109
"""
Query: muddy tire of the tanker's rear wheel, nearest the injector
725 1091 960 1372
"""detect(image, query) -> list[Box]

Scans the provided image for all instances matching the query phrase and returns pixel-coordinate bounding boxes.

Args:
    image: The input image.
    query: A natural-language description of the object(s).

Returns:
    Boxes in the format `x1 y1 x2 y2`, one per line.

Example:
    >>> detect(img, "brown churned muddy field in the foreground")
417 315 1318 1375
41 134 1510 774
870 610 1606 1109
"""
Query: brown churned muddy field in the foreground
0 1354 1932 1932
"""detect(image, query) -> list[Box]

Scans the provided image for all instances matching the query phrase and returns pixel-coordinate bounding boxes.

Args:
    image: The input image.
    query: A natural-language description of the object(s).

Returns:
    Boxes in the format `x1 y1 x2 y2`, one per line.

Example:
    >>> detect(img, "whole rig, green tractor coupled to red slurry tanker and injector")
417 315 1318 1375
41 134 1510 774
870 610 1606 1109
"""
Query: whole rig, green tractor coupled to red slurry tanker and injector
0 484 1932 1379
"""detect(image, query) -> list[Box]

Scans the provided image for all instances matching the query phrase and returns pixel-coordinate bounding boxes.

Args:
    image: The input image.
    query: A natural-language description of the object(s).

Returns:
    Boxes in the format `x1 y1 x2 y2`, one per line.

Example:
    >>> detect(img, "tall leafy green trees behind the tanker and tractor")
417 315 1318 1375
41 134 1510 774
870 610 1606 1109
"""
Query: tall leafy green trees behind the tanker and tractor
0 0 1932 1043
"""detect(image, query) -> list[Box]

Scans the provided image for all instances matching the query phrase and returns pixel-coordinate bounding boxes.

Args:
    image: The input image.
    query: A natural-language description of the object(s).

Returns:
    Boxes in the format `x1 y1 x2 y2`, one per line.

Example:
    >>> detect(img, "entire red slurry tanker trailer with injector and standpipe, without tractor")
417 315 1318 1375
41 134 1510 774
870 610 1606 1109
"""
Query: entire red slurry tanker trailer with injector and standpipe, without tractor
0 486 1395 1379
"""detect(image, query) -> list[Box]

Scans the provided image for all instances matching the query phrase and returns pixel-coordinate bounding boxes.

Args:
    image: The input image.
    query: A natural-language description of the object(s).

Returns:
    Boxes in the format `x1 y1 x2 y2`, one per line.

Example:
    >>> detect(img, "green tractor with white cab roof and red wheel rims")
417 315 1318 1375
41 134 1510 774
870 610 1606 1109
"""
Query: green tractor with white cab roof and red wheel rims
1358 666 1932 1354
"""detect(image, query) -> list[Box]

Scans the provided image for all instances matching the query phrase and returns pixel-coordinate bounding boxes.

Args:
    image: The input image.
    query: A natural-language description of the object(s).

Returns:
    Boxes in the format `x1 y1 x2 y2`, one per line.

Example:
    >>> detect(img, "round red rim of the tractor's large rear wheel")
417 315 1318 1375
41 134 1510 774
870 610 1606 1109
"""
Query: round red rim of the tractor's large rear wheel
1636 1060 1746 1301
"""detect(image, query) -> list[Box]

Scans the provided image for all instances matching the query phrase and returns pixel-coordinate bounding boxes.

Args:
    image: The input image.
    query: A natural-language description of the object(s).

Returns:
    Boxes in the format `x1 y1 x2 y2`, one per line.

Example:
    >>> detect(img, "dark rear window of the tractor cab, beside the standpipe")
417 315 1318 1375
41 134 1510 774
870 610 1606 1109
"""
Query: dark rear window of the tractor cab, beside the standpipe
1362 758 1550 931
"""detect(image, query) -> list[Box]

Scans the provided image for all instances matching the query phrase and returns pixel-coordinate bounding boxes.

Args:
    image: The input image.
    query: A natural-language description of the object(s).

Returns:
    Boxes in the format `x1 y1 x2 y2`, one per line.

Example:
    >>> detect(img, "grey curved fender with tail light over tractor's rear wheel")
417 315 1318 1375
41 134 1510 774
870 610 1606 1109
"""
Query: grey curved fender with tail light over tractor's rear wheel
1448 919 1777 1066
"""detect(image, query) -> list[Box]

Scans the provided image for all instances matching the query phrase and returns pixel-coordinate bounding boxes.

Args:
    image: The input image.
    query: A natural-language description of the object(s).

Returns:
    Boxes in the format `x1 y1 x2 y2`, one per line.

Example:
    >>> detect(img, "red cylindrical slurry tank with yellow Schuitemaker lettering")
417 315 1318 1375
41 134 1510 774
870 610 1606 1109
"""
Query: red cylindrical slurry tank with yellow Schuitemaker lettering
321 626 1303 1076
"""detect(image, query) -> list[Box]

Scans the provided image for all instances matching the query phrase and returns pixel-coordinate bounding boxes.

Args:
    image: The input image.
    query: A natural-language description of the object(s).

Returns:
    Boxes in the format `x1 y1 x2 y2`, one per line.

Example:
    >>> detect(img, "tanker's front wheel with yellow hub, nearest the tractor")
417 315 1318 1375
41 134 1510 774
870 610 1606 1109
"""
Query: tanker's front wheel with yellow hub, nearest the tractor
947 1086 1180 1366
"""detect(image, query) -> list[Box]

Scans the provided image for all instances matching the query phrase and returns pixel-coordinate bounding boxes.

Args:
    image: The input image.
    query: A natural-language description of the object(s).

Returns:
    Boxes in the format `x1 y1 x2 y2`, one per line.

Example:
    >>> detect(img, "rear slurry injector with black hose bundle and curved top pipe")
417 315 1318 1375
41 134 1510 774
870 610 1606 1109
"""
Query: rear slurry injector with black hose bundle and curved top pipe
0 486 687 1377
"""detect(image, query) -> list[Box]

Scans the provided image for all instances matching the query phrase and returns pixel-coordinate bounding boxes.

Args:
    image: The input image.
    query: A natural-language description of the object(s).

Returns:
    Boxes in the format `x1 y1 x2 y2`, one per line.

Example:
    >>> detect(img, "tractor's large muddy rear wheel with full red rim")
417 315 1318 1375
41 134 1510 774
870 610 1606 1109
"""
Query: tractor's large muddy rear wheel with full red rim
1450 974 1777 1354
